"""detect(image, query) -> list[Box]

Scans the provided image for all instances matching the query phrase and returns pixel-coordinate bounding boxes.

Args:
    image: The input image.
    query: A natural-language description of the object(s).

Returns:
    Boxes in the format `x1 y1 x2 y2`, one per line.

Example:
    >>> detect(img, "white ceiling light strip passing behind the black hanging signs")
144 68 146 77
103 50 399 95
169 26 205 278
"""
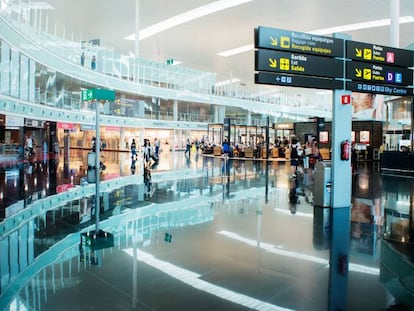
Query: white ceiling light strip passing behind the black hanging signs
217 15 414 57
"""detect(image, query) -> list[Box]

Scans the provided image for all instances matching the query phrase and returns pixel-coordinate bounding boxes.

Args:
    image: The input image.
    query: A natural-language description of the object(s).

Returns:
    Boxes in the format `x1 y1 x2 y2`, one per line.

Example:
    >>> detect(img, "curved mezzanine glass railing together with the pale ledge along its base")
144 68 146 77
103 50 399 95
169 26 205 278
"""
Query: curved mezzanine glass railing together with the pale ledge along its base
0 4 331 122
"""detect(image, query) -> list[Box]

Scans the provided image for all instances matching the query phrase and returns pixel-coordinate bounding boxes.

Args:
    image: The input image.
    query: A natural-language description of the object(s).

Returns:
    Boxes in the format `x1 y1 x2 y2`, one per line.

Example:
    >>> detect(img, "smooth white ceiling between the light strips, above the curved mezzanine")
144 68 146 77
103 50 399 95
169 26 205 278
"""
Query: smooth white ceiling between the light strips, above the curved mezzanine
46 0 414 90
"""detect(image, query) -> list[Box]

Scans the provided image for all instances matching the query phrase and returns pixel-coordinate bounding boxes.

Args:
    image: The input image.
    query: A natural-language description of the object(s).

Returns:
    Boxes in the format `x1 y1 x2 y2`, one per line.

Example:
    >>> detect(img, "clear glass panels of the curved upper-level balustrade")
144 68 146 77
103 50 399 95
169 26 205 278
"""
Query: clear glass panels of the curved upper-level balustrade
0 0 331 115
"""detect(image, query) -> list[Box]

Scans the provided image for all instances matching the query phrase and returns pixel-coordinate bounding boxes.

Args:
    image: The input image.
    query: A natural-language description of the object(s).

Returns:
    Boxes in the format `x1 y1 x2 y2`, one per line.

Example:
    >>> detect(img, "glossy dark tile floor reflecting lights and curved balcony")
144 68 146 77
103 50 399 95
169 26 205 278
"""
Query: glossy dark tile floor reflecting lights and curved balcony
0 151 414 310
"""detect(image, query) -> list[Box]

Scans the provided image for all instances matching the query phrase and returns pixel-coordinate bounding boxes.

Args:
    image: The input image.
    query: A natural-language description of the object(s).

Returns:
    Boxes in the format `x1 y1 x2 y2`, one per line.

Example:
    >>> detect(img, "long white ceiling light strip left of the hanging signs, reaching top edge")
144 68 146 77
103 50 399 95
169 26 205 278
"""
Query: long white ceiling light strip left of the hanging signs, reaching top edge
125 0 253 40
